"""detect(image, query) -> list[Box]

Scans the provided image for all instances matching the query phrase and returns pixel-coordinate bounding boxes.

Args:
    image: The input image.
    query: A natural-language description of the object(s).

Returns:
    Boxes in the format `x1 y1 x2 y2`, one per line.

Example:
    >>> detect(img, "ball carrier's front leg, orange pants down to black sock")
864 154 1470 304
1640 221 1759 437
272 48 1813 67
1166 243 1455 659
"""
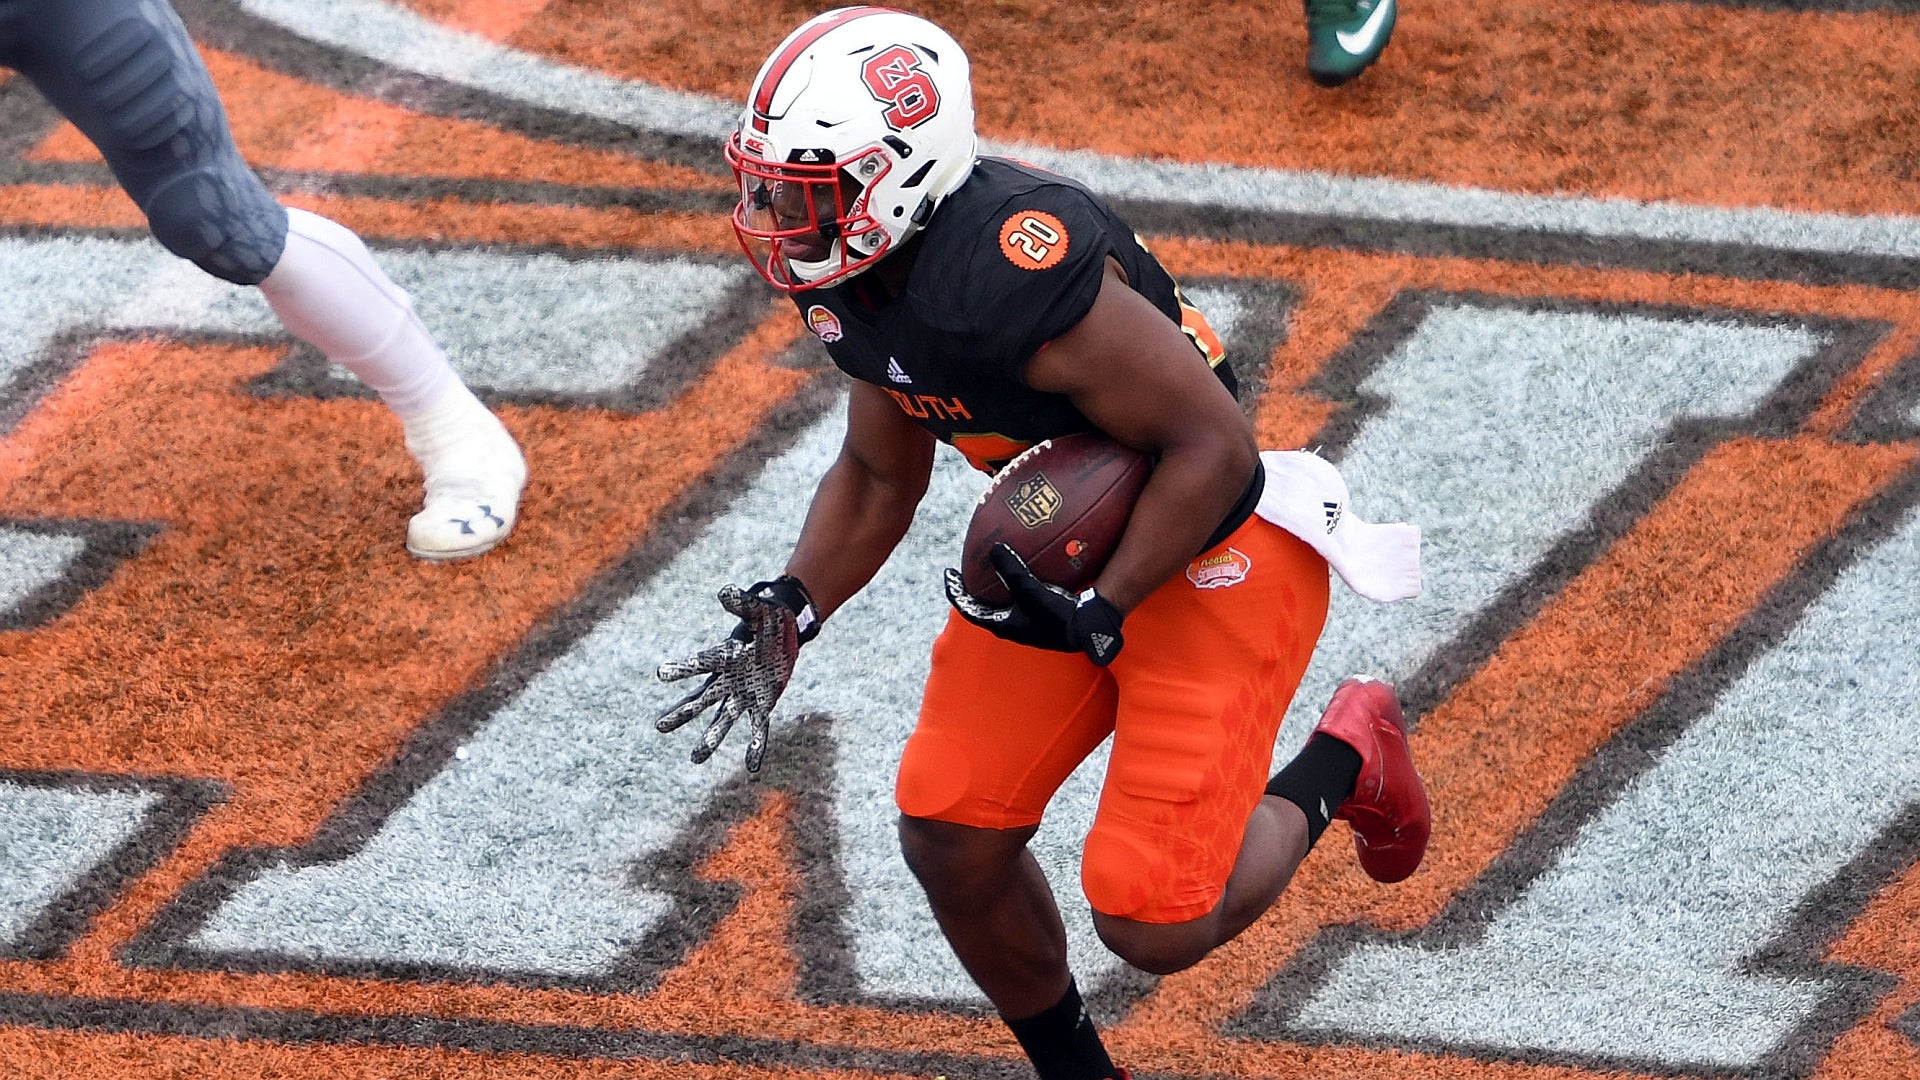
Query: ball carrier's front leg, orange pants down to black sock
895 617 1123 1080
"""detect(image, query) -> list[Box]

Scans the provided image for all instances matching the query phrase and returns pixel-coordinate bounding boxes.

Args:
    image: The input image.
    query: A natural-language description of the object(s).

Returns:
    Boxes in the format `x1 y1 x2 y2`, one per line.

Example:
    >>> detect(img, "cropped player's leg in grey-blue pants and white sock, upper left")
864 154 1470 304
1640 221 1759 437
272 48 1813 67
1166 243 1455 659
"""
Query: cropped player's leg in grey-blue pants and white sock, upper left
0 0 526 561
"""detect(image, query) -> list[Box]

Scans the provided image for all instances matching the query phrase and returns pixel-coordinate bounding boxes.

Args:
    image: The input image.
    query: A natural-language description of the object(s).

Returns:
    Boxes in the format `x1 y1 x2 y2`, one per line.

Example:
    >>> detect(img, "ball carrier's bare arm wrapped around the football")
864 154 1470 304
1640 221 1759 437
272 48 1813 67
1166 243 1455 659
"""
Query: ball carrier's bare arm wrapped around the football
1025 259 1260 611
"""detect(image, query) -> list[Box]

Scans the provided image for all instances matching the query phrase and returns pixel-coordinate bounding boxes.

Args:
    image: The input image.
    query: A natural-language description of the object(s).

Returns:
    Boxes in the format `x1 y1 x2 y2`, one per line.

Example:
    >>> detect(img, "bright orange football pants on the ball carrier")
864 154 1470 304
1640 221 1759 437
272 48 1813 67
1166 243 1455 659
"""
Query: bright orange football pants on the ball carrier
895 517 1329 922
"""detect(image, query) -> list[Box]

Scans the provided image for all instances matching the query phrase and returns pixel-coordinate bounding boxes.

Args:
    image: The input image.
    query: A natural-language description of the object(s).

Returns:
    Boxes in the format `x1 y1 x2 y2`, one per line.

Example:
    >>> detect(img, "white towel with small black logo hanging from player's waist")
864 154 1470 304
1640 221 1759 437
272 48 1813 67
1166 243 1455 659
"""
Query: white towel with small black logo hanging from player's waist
1254 450 1421 603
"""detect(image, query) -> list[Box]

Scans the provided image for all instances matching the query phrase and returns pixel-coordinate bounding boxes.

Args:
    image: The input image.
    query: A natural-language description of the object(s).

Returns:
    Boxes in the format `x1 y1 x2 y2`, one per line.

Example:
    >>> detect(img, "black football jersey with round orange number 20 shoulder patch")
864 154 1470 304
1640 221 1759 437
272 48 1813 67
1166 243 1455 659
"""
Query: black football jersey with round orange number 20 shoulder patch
793 158 1238 473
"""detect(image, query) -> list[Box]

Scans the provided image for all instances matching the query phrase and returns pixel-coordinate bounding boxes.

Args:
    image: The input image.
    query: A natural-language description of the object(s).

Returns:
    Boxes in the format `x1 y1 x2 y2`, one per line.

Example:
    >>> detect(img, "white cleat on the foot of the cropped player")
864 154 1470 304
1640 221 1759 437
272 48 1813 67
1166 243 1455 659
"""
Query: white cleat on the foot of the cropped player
407 394 526 563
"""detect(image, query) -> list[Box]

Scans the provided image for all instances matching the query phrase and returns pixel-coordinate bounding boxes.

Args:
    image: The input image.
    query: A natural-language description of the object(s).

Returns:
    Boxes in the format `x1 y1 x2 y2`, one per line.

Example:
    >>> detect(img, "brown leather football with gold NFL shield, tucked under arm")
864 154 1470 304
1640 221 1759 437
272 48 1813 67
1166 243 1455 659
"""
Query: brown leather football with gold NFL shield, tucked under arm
960 430 1154 605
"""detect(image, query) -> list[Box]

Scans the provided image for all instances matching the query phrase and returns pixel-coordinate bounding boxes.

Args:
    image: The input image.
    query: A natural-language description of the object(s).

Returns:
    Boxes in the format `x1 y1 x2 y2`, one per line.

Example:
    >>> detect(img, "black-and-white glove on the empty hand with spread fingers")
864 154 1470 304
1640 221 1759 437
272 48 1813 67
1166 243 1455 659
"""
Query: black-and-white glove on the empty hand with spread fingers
653 577 820 773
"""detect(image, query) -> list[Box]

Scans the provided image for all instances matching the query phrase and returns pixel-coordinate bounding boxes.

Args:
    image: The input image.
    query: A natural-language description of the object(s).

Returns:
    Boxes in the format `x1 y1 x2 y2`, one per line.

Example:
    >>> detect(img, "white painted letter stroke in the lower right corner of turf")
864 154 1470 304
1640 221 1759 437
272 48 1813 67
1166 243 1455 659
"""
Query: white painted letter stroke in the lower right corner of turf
1296 495 1920 1068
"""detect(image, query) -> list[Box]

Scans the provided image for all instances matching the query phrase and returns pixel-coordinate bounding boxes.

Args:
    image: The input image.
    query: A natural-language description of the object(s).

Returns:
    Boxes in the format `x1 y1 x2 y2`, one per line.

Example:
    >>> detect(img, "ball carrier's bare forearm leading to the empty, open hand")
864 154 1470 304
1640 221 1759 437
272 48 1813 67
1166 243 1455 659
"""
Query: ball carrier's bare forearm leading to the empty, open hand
785 382 935 619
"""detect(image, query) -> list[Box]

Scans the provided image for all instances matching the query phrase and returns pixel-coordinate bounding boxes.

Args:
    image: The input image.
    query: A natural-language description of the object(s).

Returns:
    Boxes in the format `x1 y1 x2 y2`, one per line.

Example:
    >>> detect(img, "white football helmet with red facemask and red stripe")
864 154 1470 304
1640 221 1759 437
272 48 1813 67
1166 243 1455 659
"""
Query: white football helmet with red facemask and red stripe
726 8 977 292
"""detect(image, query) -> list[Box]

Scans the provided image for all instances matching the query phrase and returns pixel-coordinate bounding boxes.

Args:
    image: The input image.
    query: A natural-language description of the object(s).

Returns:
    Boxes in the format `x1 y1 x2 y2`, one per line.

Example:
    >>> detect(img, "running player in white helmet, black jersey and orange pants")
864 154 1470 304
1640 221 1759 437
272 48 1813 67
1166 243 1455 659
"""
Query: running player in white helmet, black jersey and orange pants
659 8 1428 1080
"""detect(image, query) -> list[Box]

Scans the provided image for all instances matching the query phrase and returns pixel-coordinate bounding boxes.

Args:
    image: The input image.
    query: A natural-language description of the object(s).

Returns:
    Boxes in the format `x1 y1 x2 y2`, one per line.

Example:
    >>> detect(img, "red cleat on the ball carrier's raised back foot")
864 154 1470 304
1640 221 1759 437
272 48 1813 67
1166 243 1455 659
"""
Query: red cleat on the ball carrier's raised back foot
1313 675 1432 882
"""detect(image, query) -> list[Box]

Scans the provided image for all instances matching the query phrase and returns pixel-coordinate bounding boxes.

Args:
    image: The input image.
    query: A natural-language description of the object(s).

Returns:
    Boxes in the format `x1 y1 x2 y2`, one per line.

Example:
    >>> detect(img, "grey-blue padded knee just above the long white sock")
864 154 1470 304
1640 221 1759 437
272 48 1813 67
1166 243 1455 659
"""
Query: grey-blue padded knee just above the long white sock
144 158 286 284
